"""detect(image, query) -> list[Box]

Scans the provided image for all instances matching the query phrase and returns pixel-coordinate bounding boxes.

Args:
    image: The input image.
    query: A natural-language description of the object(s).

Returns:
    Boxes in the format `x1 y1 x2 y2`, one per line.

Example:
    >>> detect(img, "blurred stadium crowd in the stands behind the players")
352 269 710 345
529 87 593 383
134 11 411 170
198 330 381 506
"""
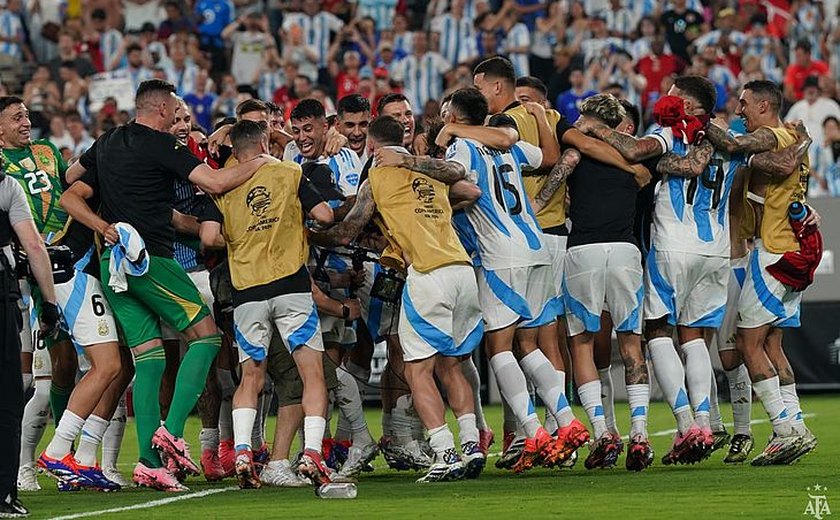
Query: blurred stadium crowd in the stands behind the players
0 0 840 196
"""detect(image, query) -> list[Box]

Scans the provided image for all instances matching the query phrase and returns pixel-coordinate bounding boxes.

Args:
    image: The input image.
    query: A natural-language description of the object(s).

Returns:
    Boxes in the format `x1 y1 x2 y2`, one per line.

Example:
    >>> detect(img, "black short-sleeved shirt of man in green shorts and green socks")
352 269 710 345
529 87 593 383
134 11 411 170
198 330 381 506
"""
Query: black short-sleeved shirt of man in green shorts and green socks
79 122 203 258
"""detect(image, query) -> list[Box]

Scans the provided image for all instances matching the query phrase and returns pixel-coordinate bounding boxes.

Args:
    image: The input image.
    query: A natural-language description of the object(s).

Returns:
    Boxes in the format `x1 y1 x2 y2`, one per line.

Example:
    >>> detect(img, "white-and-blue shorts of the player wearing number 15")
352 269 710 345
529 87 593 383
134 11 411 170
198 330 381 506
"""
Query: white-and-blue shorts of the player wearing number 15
476 265 558 331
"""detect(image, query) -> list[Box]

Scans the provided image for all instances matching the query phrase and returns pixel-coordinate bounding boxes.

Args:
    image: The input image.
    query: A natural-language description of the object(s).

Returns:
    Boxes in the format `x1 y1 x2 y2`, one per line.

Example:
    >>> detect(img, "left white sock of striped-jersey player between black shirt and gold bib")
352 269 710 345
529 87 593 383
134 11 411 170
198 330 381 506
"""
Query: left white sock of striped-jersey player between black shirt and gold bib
648 338 694 433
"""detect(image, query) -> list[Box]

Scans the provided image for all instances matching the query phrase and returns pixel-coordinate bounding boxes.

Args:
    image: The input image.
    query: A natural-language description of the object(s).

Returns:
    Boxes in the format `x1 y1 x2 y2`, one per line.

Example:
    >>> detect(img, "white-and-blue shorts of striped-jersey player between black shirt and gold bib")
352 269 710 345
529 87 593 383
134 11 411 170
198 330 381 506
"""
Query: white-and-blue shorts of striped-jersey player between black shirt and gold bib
644 246 729 329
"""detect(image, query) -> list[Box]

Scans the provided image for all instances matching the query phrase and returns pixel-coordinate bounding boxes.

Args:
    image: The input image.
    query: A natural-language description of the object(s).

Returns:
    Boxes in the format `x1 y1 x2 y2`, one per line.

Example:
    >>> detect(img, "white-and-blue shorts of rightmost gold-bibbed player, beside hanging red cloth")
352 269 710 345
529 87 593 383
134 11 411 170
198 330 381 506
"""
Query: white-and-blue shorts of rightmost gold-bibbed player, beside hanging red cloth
738 240 802 329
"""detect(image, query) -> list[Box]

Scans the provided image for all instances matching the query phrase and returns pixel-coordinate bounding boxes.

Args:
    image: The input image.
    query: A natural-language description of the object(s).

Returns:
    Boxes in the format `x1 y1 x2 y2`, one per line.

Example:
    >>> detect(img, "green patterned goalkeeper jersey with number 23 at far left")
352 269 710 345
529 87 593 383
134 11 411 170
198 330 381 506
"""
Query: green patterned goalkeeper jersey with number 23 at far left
3 139 70 244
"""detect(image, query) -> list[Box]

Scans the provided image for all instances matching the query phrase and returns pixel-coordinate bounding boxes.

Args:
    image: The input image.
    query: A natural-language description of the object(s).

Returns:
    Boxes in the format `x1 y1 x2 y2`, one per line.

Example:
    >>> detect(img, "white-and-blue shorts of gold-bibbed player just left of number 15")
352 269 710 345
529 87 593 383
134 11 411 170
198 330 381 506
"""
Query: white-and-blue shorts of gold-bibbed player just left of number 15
399 265 484 361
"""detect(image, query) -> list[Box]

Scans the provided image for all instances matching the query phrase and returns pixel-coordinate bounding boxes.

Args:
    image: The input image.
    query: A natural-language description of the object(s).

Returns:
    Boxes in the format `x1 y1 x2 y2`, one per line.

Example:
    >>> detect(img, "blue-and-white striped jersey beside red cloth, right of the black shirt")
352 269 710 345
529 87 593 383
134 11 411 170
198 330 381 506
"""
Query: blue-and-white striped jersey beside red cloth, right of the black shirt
649 127 746 258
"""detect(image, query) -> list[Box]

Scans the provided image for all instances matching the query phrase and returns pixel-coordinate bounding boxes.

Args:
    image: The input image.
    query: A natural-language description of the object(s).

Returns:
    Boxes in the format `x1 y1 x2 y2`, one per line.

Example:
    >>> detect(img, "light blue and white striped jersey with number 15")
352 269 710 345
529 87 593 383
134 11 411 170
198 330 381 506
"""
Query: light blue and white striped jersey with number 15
446 138 551 271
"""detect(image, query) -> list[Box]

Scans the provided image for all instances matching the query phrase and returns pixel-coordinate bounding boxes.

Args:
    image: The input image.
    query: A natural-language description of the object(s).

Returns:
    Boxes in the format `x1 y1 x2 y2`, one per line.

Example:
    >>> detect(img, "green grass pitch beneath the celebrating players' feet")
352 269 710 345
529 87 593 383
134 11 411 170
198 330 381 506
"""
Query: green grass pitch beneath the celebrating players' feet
16 396 840 520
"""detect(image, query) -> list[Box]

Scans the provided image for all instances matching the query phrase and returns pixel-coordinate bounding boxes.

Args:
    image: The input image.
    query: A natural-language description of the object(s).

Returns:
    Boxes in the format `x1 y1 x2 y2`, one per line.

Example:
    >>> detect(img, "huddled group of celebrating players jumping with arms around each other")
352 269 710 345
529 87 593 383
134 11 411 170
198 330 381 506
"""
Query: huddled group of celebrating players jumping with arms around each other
0 53 822 492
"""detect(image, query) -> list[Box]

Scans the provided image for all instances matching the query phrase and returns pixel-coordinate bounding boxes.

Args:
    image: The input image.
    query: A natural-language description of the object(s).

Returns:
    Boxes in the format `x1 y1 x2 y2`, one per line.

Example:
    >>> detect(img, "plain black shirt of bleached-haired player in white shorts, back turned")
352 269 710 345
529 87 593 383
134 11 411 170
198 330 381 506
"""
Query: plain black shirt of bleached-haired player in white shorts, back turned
566 156 638 247
